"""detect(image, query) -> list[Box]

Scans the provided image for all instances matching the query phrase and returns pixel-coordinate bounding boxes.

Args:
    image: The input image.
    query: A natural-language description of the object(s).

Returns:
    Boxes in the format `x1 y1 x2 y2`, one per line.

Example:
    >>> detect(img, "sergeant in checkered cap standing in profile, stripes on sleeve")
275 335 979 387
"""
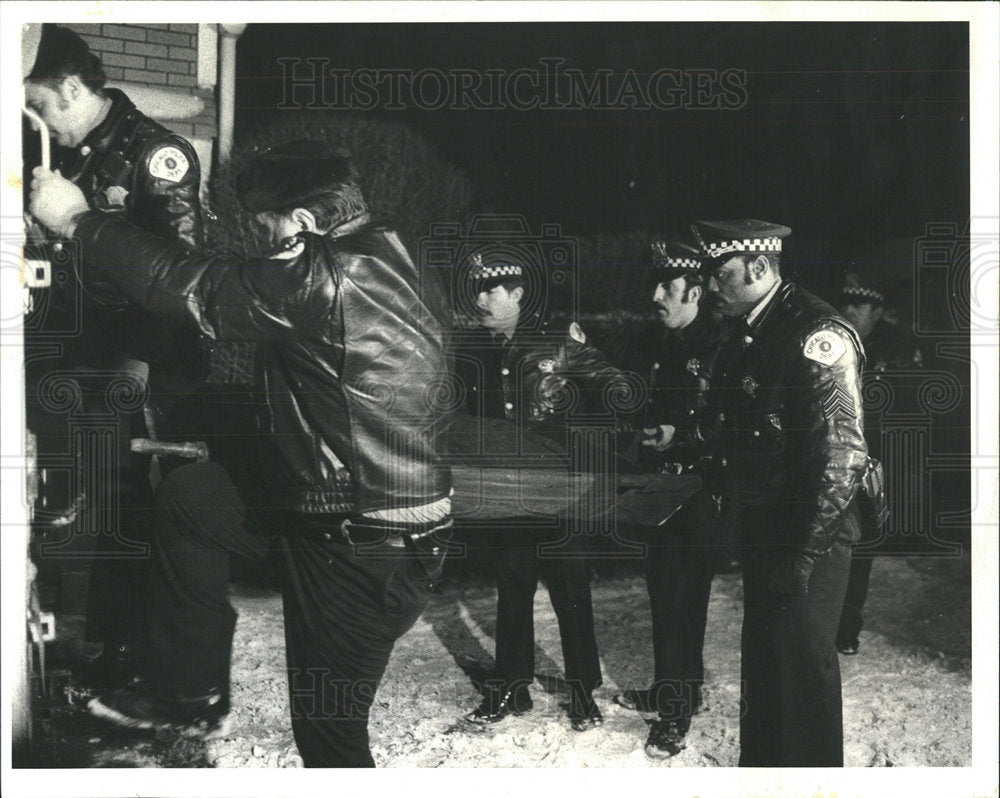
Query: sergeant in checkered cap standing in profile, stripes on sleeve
692 219 867 767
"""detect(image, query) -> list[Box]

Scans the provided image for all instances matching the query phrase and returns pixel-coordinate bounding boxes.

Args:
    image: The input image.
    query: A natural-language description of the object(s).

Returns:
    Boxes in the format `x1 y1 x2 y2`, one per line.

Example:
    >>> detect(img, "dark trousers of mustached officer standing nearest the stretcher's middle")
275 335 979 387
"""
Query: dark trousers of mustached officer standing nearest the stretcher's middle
492 521 601 708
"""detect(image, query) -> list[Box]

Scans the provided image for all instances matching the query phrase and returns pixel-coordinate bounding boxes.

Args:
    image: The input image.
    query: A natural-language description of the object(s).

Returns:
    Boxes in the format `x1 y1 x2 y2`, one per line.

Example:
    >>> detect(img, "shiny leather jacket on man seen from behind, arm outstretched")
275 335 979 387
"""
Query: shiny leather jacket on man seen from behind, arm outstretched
76 211 451 514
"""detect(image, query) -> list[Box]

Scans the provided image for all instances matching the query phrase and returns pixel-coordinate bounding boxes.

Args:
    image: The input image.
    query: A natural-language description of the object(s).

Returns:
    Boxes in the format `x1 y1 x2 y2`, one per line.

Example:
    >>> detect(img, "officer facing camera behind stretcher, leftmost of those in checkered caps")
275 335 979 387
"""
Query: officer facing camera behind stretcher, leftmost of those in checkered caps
455 251 623 731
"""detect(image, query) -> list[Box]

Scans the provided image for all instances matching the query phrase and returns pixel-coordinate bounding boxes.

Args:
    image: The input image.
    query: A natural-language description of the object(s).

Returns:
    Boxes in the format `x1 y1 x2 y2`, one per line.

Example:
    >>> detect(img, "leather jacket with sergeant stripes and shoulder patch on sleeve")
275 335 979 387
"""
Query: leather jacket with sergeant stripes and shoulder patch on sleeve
712 282 868 559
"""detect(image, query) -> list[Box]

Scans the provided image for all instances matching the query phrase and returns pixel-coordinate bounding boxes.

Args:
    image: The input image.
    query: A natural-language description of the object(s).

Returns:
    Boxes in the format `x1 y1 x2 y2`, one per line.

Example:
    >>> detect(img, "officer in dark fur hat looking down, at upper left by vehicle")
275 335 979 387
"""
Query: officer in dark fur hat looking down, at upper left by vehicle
25 24 203 682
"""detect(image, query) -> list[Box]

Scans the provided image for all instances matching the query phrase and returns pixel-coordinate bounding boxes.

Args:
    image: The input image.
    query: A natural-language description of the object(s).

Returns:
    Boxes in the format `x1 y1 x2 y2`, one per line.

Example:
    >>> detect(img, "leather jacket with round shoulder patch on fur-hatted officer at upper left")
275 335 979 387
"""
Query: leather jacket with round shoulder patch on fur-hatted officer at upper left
56 89 203 249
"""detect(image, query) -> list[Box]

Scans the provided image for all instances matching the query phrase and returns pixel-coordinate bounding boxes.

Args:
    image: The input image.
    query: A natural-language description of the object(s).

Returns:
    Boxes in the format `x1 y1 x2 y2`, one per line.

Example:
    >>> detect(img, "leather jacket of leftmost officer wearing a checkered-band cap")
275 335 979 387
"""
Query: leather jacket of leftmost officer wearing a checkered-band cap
454 316 641 440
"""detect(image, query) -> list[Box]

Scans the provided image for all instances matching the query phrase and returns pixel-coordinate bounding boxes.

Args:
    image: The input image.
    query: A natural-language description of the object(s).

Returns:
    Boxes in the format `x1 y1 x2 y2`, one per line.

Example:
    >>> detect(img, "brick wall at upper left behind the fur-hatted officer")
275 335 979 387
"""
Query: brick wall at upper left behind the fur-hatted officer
67 23 218 139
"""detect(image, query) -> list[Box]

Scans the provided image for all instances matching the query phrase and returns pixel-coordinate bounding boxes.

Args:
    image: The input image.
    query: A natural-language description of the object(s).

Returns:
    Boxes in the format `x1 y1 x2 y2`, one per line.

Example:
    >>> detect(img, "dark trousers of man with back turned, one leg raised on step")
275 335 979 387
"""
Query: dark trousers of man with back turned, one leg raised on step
145 463 444 767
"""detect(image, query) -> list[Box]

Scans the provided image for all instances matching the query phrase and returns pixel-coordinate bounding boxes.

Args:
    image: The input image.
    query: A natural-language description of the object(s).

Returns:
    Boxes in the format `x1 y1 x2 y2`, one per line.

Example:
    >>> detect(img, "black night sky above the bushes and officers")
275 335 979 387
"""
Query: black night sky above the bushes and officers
236 23 969 254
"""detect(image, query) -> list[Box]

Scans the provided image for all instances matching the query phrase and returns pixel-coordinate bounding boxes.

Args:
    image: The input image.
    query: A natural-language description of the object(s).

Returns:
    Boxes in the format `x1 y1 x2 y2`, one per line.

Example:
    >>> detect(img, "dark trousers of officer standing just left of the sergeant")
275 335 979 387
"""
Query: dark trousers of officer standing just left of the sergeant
645 490 716 721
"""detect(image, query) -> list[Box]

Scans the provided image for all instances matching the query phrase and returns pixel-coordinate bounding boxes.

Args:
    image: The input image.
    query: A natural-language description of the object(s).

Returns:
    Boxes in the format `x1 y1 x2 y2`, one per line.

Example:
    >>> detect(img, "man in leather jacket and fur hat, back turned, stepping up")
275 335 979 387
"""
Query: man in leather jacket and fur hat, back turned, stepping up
32 141 451 767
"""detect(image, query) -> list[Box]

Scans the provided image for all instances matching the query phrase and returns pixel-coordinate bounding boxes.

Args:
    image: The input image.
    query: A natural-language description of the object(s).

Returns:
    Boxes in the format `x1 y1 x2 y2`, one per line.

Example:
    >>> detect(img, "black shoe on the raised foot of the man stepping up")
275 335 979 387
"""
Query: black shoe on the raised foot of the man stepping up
87 679 231 740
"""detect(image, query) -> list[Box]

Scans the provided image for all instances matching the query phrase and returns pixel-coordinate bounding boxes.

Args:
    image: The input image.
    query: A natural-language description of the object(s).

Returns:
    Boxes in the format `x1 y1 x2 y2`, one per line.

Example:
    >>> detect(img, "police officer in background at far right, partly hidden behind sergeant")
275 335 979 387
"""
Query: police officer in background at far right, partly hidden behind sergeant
837 272 923 655
